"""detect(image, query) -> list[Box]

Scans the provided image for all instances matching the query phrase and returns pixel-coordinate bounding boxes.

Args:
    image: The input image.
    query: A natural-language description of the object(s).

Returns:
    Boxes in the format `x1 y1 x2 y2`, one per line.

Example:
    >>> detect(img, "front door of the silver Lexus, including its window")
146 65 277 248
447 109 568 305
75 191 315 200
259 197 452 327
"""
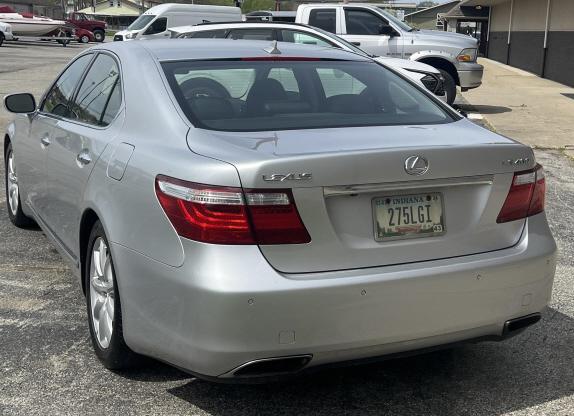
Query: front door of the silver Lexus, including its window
18 53 93 224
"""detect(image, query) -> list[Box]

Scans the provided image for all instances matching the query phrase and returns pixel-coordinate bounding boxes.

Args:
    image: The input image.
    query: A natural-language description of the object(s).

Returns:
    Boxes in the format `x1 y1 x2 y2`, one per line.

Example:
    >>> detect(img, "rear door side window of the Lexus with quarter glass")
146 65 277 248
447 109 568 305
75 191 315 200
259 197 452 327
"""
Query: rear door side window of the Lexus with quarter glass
73 54 122 126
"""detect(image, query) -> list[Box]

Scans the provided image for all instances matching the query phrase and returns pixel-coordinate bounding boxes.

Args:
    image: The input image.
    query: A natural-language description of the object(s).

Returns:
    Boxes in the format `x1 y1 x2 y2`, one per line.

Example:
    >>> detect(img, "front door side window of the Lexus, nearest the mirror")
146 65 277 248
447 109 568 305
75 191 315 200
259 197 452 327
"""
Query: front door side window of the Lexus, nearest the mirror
42 54 93 117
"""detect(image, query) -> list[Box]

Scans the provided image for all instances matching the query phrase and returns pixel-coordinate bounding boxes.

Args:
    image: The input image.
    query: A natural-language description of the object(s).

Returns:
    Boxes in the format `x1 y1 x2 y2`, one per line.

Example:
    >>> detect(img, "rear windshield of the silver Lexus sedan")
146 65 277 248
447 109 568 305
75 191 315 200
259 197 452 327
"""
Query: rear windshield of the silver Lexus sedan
163 60 460 131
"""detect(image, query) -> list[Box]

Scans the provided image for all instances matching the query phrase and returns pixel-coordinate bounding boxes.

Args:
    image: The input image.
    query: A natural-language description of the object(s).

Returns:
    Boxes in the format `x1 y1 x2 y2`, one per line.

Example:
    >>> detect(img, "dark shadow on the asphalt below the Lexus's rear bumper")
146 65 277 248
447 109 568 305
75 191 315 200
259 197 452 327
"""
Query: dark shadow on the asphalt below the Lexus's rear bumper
161 309 574 416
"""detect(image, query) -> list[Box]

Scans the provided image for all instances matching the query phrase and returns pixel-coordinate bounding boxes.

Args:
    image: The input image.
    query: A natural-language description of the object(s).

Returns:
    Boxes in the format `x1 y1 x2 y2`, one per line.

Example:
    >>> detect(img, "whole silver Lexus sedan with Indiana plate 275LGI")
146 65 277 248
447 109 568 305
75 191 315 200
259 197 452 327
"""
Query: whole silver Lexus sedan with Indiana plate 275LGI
3 39 556 380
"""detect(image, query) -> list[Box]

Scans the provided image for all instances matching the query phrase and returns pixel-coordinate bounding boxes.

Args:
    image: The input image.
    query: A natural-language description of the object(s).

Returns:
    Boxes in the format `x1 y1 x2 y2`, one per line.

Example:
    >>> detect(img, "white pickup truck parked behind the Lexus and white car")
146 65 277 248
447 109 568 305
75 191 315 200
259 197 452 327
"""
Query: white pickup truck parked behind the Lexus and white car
295 3 483 104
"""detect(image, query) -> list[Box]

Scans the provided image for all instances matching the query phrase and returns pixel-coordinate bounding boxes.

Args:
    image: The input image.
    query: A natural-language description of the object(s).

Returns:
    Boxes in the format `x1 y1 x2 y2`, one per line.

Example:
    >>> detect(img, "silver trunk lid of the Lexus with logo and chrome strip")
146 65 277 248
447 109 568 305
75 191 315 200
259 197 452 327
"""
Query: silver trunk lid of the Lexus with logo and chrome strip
188 120 535 273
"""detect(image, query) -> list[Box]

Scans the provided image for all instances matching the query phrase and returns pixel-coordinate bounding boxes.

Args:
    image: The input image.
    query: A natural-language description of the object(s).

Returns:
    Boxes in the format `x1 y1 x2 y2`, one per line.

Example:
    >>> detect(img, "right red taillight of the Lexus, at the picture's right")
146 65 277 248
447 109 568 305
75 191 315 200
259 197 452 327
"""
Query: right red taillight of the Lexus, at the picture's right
496 165 546 223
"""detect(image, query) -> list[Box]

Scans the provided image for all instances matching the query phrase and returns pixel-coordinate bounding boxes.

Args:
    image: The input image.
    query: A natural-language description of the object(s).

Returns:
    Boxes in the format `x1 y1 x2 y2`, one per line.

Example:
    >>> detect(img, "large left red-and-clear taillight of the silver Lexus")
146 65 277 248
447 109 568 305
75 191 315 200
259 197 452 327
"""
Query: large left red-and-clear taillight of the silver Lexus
155 175 311 244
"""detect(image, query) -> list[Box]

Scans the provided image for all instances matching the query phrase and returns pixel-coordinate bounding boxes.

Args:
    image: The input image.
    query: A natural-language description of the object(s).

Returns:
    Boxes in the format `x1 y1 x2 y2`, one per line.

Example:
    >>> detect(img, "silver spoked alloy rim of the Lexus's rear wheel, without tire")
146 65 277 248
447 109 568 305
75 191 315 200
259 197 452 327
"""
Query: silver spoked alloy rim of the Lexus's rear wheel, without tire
90 237 115 349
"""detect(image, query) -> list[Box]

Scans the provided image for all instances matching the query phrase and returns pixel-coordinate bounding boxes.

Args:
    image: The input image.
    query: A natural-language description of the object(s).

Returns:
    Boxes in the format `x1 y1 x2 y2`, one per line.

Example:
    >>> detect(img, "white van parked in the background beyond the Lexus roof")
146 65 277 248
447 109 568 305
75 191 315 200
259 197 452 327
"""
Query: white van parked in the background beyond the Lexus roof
114 3 242 41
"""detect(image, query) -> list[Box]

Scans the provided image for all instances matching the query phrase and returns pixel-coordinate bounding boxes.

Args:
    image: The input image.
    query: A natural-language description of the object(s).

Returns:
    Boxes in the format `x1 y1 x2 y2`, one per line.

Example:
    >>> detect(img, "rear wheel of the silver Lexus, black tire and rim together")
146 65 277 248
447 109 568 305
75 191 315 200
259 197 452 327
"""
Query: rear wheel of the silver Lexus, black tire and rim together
84 221 139 370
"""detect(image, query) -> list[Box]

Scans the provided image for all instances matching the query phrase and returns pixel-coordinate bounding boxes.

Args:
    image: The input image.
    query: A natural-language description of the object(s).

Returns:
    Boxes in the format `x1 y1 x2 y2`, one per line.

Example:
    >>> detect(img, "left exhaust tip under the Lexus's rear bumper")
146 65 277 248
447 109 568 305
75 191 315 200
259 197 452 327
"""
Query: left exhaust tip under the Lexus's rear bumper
233 355 312 377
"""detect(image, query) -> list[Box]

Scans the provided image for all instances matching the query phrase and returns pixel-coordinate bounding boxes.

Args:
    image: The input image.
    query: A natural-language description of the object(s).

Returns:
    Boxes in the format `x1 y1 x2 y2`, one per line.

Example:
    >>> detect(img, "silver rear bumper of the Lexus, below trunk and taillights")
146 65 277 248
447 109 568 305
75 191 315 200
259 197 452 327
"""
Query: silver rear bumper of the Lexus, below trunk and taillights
112 214 556 378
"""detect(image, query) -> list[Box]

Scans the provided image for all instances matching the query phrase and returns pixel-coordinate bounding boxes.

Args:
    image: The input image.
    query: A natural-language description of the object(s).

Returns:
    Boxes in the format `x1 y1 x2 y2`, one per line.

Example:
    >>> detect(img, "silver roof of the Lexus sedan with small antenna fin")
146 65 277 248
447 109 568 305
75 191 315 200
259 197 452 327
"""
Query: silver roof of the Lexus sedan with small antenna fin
97 39 372 62
